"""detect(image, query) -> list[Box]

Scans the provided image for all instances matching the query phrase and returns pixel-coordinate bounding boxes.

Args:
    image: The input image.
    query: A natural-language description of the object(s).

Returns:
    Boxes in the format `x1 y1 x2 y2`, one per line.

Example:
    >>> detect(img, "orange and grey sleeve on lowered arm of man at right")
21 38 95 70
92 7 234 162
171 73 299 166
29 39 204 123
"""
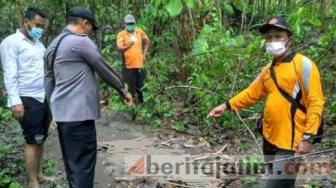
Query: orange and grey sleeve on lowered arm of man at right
303 61 325 135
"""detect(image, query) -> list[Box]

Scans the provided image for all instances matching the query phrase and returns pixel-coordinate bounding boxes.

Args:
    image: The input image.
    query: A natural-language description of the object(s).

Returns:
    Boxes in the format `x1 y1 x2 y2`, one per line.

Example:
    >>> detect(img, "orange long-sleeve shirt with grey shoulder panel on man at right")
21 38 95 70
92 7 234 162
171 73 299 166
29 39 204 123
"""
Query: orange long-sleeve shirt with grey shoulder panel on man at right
229 53 324 150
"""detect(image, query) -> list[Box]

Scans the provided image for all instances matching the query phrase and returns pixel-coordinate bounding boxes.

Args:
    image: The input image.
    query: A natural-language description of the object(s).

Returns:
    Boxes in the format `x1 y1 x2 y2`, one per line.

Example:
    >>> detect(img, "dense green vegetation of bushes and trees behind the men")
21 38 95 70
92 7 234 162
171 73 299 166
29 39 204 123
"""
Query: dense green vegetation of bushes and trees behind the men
0 0 336 187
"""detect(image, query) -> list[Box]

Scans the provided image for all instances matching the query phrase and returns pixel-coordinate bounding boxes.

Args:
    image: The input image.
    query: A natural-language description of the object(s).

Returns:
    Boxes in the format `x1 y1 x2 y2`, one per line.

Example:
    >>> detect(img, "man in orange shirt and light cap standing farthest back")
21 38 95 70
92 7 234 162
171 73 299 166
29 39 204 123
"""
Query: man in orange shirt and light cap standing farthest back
117 15 150 104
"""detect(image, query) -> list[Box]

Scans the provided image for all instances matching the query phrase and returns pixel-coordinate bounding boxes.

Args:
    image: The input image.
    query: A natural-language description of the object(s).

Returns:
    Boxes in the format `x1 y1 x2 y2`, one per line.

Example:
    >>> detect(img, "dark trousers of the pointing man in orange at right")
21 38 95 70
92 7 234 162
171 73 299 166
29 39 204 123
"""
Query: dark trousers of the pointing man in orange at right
263 139 297 188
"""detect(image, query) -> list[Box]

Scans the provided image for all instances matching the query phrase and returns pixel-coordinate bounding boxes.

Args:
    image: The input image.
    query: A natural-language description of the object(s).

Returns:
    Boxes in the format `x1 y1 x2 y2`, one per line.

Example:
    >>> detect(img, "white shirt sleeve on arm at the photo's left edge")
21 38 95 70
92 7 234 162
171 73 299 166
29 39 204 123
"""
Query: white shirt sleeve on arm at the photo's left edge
0 40 22 107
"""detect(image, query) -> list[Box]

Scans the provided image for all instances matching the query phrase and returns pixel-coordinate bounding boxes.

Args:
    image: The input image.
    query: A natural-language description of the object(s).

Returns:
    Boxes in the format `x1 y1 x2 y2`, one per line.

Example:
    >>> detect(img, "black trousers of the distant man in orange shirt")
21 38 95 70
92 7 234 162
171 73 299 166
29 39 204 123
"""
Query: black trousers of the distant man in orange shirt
122 68 147 103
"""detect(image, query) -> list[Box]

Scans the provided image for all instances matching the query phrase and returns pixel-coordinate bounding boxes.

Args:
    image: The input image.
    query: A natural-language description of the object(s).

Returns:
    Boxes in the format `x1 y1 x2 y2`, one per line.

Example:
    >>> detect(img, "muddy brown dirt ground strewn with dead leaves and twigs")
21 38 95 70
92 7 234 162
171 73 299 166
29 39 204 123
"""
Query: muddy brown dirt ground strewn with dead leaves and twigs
7 110 335 188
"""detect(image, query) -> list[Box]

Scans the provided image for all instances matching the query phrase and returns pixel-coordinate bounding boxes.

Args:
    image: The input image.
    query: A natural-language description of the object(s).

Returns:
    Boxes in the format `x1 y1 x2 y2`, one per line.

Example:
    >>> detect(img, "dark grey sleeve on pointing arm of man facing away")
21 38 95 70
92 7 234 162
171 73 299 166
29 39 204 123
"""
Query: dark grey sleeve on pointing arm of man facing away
80 37 127 96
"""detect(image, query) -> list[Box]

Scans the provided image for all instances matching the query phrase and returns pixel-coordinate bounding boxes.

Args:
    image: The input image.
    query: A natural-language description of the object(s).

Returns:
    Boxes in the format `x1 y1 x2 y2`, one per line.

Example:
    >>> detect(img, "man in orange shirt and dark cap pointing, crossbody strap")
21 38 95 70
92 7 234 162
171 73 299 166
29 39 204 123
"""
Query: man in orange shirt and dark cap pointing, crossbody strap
209 17 324 188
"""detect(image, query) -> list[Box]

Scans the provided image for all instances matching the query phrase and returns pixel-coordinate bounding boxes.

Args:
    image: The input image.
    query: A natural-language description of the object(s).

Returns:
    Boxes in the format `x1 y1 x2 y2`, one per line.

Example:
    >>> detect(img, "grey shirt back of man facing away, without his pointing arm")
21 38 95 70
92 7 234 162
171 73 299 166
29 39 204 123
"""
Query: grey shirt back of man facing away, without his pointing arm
46 31 100 122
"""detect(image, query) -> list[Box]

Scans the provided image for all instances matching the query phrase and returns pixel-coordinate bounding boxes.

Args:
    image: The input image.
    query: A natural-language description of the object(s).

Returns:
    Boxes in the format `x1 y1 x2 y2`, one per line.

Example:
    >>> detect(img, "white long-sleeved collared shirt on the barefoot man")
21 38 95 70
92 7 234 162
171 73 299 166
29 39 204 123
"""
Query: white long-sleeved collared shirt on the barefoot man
0 30 45 107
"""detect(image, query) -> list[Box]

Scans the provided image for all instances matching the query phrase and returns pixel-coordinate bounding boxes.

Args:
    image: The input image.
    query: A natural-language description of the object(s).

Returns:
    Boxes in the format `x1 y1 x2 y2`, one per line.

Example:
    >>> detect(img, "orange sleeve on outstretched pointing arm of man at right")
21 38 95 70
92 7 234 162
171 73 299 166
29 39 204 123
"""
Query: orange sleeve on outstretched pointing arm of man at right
228 65 267 111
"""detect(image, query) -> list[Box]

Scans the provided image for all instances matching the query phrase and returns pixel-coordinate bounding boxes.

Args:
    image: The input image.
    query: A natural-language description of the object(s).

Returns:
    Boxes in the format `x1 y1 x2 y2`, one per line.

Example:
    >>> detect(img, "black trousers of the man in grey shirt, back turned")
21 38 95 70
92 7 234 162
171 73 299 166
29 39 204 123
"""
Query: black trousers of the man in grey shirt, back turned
57 120 97 188
